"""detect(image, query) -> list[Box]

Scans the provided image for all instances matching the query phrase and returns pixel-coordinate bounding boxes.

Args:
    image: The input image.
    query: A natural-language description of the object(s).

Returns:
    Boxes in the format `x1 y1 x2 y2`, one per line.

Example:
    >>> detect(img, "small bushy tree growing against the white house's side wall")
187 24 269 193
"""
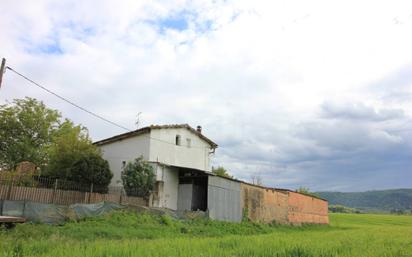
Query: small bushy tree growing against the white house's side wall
122 156 156 197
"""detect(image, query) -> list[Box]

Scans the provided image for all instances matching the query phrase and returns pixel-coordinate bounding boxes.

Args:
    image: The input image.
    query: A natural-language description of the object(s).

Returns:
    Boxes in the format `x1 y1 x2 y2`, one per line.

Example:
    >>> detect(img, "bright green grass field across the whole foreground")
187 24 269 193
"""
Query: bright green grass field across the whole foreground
0 211 412 257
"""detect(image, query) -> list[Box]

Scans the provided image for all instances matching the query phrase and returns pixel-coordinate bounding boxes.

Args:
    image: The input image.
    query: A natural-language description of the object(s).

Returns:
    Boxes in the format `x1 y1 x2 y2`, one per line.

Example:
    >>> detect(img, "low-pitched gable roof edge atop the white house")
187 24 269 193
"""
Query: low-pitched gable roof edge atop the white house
93 124 218 148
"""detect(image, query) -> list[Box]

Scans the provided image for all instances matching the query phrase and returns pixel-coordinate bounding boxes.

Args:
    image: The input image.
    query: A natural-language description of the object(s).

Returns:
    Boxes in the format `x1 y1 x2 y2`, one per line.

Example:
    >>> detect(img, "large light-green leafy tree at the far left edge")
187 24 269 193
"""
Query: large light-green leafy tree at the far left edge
0 97 61 170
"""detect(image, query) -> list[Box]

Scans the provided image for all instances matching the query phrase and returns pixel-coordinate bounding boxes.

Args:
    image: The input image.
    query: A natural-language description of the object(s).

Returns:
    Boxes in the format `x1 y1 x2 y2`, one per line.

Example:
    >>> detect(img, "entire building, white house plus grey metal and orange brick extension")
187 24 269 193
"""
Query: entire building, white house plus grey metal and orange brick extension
95 124 328 224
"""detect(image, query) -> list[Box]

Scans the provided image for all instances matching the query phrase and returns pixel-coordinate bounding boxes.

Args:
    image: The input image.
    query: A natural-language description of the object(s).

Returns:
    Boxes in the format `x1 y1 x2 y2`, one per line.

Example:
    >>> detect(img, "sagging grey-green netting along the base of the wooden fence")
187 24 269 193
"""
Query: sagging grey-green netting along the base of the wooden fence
0 200 125 224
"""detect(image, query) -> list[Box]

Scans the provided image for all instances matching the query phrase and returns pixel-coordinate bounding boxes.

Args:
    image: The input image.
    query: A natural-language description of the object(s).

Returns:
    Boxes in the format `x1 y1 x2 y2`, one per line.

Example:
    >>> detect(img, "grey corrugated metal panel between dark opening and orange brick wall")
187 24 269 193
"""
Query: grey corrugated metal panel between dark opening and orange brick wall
207 176 242 222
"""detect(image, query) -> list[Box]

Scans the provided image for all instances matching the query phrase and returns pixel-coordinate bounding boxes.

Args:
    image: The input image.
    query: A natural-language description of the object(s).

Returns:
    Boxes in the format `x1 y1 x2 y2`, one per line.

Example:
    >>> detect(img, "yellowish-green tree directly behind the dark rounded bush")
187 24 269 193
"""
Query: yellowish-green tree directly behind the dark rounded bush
44 119 101 177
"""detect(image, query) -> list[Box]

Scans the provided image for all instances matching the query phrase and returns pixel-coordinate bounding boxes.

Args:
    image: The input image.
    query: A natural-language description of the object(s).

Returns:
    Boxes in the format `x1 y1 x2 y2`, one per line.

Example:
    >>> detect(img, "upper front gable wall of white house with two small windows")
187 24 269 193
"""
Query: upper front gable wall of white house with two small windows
149 128 210 171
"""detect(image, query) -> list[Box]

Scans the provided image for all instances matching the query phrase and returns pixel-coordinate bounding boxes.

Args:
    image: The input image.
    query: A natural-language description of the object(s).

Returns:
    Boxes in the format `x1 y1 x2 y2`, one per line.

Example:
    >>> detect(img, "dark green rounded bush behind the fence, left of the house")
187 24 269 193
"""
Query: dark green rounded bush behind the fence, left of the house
67 154 113 193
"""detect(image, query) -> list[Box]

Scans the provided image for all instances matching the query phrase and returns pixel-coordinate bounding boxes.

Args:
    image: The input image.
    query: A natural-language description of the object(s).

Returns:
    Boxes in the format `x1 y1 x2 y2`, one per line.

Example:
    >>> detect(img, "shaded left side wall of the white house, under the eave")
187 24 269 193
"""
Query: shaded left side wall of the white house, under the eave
99 134 150 186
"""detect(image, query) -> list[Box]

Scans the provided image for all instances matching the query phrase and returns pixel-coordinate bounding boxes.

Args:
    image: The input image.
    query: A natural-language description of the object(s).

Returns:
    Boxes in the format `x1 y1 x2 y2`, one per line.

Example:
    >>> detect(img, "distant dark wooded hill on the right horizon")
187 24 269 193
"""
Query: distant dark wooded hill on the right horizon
316 189 412 212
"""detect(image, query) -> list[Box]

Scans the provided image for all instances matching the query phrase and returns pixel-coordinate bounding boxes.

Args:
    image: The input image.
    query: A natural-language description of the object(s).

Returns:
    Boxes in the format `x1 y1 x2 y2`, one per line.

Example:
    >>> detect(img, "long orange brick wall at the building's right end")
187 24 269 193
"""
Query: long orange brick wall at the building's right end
241 183 329 224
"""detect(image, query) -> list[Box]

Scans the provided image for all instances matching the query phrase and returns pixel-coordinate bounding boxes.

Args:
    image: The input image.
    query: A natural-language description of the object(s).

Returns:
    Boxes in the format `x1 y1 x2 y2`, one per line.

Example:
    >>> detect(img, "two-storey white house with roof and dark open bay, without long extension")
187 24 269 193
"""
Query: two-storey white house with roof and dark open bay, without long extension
95 124 217 210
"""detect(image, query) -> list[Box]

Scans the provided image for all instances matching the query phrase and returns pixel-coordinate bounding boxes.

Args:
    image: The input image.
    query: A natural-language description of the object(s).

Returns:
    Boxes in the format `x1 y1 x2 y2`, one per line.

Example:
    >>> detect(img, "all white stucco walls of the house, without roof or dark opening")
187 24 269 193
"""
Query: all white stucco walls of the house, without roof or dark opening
95 128 211 210
